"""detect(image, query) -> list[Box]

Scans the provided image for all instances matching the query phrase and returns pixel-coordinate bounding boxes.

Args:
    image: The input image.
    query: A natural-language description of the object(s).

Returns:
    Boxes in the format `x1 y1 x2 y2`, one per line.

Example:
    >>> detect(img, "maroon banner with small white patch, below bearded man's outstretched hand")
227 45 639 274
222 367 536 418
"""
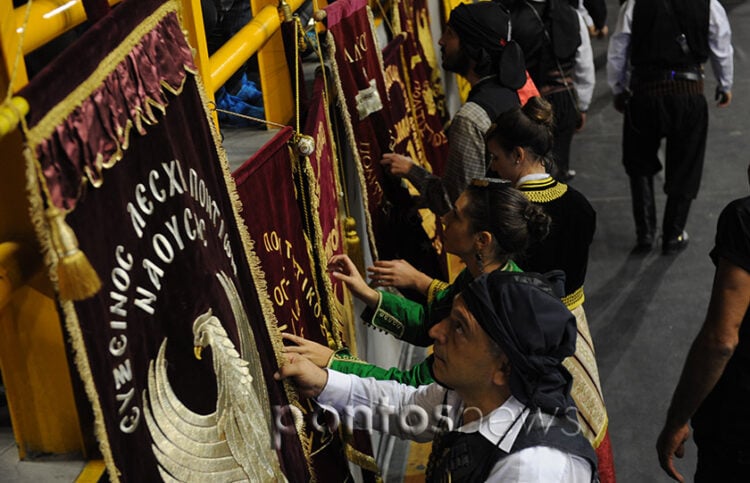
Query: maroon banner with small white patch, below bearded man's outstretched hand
325 0 440 276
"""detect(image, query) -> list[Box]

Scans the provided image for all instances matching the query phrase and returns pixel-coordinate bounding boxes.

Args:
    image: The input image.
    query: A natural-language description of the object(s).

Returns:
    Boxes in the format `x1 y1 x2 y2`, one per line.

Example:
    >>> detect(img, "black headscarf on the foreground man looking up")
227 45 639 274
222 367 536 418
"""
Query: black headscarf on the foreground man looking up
462 270 577 413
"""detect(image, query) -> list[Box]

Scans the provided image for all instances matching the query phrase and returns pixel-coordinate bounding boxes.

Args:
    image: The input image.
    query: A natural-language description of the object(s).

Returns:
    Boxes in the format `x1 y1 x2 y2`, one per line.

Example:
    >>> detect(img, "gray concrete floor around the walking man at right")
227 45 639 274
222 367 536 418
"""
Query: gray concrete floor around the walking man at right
0 0 750 483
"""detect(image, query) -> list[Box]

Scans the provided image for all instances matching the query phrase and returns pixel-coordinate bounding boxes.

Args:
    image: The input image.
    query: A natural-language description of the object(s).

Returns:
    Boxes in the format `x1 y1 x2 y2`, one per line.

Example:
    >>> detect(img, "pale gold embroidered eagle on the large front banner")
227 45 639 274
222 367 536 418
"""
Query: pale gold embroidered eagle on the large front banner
143 309 286 482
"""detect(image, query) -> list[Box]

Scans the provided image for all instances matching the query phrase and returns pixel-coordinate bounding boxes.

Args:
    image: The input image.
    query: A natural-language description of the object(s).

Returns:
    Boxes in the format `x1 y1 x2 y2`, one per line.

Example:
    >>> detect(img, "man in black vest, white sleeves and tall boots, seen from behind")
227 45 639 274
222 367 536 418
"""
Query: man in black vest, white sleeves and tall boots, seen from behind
607 0 734 255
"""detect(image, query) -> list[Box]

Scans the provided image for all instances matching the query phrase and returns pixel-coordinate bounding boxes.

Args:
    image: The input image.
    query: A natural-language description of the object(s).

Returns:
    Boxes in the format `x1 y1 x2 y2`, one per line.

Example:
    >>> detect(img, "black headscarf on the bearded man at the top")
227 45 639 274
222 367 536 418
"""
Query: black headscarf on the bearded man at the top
448 2 526 89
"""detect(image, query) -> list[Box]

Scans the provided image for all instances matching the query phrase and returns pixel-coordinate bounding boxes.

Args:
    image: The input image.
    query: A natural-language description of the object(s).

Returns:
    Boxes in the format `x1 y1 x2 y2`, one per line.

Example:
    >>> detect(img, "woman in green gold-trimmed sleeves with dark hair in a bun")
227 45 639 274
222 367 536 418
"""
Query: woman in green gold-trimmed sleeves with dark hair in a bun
284 179 550 385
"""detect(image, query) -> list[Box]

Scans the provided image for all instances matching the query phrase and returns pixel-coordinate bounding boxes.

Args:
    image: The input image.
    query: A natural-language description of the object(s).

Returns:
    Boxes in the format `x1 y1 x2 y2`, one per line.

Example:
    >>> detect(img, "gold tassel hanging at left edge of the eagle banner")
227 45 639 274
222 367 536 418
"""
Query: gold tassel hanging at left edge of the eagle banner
46 207 102 300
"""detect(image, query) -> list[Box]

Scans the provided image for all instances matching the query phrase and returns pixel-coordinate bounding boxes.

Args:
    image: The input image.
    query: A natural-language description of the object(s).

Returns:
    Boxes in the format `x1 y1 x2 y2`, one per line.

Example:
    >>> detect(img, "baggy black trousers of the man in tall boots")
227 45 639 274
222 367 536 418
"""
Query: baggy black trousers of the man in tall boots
622 91 708 199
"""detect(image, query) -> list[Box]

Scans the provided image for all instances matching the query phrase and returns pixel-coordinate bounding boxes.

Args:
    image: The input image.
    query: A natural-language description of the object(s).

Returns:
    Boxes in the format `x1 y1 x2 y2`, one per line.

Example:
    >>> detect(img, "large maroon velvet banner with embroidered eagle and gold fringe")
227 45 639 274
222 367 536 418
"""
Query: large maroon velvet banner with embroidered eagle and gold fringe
20 0 310 482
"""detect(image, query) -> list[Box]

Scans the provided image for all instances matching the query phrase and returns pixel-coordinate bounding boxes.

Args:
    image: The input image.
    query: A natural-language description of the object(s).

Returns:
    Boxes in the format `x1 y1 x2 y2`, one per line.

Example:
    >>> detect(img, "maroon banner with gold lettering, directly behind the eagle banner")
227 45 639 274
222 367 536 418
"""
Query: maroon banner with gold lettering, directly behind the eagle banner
233 127 358 481
